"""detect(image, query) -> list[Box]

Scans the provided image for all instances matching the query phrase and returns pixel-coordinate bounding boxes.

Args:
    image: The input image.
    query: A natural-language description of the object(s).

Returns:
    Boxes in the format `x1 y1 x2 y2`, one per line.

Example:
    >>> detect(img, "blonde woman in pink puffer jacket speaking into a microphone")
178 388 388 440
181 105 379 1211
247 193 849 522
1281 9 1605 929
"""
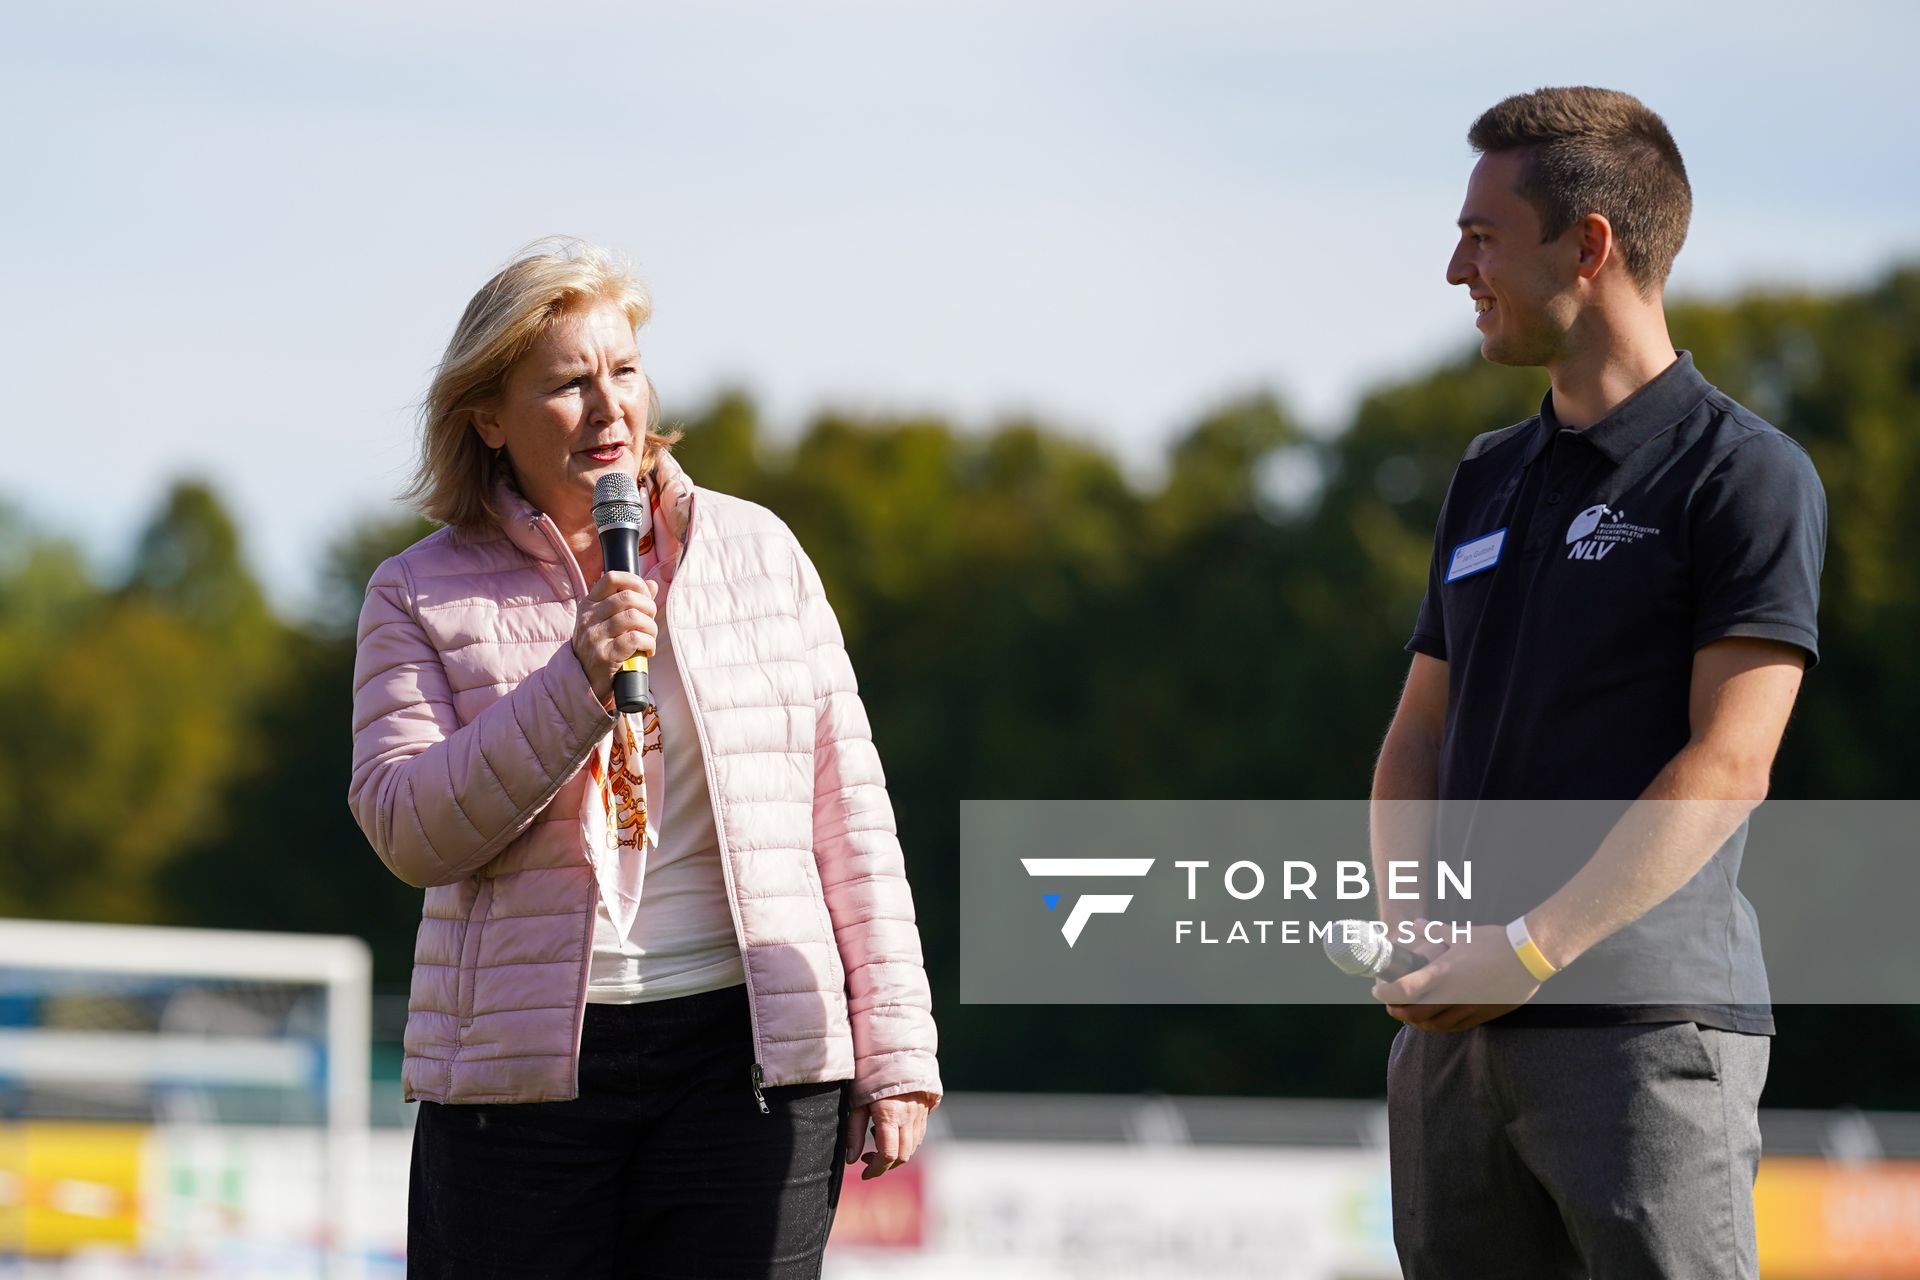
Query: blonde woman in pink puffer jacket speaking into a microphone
349 240 941 1278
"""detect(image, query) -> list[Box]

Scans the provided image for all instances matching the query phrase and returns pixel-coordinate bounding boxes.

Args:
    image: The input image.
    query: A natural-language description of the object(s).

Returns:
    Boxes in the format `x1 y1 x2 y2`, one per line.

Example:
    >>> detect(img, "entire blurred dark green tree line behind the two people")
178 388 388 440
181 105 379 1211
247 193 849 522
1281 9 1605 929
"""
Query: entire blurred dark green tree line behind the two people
0 269 1920 1107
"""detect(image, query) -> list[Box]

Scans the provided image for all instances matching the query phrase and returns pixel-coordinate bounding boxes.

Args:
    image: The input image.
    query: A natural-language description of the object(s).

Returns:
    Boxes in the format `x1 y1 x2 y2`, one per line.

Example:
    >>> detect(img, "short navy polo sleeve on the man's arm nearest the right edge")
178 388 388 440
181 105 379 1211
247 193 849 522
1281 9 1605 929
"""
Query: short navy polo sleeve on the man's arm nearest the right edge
1688 432 1826 670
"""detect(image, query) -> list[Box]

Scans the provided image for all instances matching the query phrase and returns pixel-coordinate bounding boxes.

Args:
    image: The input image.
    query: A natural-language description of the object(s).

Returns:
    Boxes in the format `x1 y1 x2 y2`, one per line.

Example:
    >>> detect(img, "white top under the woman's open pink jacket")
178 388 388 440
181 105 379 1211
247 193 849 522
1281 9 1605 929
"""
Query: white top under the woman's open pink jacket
588 591 747 1004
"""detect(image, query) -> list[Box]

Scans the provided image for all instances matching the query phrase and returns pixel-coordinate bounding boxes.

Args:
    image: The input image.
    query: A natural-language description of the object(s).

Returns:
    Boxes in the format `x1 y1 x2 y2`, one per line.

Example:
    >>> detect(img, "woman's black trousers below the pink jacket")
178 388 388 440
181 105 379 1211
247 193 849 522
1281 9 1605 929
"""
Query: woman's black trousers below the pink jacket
407 986 849 1280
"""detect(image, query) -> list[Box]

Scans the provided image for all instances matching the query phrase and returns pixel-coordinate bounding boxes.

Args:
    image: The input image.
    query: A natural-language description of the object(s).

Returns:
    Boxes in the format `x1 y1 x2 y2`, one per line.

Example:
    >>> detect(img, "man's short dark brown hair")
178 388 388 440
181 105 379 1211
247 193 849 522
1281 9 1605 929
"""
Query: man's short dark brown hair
1467 88 1693 294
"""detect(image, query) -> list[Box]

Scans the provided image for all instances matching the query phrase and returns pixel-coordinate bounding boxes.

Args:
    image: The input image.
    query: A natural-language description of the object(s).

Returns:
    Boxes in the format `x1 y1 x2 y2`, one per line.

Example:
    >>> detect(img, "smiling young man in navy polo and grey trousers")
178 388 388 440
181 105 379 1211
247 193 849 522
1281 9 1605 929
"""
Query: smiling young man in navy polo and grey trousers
1373 88 1826 1280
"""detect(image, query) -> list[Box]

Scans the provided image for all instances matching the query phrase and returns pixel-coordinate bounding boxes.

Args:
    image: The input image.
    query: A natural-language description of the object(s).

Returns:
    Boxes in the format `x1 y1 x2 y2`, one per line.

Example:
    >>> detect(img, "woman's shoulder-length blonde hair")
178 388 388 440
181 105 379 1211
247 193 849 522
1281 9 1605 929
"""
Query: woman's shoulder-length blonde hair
401 236 680 528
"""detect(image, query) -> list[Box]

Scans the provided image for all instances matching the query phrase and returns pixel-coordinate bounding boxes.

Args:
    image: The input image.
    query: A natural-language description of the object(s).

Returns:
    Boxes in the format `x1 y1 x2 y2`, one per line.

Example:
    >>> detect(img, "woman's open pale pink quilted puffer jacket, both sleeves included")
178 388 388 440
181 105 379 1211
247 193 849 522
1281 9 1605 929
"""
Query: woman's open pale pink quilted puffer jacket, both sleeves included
348 457 941 1105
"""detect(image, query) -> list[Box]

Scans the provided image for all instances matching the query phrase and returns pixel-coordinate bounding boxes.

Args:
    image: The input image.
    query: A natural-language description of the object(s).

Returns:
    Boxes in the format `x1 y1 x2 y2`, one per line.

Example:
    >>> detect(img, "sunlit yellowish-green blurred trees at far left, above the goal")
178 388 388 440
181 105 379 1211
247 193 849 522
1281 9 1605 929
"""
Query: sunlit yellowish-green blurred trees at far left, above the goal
0 482 292 921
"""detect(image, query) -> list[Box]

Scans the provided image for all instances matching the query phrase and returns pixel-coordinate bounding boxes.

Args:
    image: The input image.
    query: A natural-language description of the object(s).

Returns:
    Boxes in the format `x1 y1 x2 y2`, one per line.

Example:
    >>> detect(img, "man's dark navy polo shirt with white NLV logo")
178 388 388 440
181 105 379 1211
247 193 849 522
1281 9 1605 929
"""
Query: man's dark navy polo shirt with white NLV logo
1407 353 1826 1031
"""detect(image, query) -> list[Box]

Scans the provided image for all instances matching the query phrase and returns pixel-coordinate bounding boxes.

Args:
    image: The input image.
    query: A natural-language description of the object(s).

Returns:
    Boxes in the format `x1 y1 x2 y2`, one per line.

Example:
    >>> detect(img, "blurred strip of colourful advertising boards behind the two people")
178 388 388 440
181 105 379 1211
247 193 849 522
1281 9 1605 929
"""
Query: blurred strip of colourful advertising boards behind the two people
0 1121 1920 1280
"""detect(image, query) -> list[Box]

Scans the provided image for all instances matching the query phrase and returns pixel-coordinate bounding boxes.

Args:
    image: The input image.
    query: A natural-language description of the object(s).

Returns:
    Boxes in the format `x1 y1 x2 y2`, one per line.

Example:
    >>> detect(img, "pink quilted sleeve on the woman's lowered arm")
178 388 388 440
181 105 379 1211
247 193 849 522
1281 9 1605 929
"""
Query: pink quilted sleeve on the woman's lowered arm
793 543 943 1105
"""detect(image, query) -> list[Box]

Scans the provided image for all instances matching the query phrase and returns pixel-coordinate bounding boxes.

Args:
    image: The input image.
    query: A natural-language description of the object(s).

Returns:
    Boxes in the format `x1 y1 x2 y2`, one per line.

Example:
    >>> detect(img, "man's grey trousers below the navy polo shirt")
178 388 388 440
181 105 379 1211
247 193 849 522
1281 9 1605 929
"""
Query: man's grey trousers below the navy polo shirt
1386 1023 1768 1280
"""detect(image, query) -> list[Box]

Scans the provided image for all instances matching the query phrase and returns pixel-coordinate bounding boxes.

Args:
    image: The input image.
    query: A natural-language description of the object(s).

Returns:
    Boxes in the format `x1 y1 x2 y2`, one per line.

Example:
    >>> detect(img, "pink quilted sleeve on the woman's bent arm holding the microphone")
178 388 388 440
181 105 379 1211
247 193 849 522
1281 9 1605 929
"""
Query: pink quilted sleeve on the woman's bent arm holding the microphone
348 557 612 889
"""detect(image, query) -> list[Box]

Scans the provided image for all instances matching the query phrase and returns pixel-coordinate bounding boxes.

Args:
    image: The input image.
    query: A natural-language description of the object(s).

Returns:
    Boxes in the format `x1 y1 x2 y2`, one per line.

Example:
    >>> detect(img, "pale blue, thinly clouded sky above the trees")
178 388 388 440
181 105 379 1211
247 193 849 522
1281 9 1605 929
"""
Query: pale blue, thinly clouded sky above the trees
0 0 1920 604
